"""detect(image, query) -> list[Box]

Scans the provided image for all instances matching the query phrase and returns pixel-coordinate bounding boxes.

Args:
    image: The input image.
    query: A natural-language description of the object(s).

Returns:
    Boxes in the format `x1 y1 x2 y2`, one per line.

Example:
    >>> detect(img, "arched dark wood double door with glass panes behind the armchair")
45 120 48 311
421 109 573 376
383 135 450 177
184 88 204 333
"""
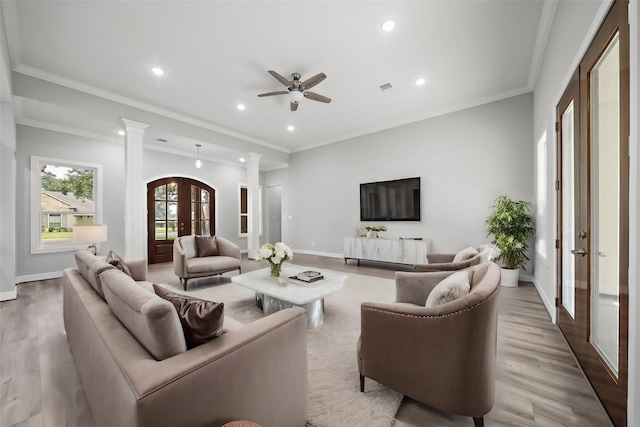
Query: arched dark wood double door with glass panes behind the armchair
147 177 215 264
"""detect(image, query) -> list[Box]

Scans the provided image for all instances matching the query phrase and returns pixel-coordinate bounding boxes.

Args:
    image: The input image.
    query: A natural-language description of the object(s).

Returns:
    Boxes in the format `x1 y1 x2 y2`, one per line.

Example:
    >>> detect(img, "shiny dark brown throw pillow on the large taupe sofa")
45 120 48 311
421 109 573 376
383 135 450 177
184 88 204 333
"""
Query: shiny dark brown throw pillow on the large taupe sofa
153 284 224 348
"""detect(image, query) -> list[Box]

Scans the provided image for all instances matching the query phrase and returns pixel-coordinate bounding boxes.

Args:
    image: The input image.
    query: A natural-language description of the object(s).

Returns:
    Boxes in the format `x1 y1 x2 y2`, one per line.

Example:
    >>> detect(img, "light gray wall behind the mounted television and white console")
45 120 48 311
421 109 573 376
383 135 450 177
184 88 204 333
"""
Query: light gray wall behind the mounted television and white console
266 94 534 256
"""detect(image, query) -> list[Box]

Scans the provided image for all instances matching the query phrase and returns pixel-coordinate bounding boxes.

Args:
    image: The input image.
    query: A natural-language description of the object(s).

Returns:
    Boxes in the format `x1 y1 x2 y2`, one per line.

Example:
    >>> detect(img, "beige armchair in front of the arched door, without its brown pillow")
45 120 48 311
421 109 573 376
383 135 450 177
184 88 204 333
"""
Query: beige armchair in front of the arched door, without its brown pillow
173 236 241 291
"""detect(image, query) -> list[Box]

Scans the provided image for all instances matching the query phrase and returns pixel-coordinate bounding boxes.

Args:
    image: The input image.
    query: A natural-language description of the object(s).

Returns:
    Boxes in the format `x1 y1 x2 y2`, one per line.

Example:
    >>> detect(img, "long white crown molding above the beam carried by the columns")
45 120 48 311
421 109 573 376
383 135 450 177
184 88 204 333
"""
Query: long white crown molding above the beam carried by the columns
13 64 291 154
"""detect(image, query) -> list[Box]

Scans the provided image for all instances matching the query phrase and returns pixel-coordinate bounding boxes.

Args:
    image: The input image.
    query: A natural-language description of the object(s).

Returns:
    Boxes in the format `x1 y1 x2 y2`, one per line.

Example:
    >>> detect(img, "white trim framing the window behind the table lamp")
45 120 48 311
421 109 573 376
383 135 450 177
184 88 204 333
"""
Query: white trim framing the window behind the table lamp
29 156 103 254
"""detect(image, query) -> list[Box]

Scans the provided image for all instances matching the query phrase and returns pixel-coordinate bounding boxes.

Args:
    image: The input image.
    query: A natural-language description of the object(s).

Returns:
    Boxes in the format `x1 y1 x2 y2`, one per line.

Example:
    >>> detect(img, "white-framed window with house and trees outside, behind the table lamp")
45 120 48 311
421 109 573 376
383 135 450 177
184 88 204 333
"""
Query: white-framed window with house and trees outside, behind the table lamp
31 156 102 253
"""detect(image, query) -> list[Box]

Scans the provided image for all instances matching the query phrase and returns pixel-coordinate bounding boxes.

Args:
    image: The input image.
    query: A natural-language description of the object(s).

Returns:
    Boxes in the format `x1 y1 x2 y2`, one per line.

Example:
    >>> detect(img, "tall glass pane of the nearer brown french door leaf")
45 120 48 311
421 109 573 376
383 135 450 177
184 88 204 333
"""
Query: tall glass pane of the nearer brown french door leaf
589 35 620 377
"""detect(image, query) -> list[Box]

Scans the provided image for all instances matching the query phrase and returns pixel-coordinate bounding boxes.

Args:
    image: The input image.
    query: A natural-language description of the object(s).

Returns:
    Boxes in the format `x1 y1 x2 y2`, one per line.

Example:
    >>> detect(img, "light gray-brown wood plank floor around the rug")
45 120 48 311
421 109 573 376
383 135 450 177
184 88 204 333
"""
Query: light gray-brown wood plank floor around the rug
0 254 612 427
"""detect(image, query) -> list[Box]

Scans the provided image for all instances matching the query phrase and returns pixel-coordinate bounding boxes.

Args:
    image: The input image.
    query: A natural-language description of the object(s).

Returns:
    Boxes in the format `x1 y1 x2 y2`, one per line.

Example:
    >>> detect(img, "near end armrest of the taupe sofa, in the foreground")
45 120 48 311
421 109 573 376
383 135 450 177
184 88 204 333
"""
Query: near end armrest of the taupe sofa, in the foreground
131 308 307 427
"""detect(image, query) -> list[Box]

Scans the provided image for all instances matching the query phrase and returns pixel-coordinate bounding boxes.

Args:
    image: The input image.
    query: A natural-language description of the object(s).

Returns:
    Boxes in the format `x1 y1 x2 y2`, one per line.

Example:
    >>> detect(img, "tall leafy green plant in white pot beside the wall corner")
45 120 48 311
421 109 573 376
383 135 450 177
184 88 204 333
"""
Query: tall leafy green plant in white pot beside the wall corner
485 196 535 287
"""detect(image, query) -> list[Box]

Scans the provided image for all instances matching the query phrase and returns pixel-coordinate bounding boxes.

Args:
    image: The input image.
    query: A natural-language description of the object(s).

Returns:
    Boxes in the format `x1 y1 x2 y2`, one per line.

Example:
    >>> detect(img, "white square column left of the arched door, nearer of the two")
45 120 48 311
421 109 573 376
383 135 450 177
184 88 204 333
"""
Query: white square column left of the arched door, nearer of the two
122 119 149 259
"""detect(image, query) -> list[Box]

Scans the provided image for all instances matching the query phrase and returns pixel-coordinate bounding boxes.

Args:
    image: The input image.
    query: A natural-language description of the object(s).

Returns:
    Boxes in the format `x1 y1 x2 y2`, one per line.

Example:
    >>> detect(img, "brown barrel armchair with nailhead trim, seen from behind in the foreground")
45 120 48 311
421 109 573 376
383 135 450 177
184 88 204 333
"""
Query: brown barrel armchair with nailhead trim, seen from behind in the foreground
358 263 500 426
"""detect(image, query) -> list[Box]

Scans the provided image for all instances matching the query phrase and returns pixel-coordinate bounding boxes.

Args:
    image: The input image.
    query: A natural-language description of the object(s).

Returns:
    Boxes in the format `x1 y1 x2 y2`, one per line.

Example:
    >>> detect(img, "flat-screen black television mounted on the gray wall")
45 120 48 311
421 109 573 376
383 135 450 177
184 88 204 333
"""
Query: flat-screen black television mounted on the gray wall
360 177 420 221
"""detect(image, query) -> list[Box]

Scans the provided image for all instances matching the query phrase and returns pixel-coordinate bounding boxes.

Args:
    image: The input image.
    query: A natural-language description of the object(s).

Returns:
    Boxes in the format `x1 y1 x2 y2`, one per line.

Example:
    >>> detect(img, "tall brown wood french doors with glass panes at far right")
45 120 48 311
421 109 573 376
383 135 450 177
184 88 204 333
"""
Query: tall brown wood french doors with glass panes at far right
557 1 629 426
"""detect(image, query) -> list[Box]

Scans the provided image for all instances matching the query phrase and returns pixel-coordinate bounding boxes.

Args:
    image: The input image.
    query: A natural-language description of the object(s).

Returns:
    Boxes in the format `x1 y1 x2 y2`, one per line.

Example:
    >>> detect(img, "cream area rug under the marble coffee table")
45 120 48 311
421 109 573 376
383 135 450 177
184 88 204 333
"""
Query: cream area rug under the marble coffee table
158 274 402 427
